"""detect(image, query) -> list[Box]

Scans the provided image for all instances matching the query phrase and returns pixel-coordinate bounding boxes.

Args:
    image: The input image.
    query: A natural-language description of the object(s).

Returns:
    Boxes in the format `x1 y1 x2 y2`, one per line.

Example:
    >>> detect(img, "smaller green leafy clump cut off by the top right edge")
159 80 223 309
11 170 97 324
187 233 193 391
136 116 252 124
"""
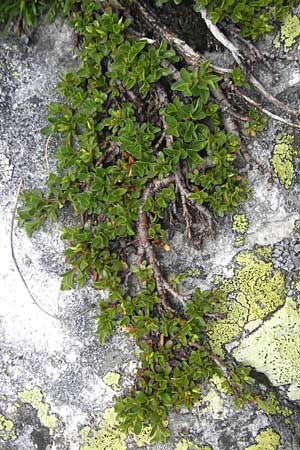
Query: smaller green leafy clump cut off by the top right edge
156 0 299 40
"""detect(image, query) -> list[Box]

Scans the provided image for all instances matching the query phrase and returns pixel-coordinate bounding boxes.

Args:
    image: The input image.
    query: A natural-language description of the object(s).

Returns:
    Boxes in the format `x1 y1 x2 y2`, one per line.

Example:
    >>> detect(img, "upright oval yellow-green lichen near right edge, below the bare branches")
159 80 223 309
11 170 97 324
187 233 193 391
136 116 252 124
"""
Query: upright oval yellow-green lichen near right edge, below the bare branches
272 133 297 189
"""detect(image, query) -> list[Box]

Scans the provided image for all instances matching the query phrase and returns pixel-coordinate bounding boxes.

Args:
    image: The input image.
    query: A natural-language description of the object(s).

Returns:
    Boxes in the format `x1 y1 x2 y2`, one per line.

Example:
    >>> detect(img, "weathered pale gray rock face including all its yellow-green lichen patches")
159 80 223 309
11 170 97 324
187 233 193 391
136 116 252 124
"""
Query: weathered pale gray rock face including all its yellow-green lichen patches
0 8 300 450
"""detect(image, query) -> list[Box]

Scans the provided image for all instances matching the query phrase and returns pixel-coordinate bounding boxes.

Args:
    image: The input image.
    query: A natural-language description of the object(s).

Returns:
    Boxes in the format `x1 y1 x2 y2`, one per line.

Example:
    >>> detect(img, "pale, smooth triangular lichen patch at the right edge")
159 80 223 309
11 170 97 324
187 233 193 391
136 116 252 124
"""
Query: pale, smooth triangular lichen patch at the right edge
233 297 300 400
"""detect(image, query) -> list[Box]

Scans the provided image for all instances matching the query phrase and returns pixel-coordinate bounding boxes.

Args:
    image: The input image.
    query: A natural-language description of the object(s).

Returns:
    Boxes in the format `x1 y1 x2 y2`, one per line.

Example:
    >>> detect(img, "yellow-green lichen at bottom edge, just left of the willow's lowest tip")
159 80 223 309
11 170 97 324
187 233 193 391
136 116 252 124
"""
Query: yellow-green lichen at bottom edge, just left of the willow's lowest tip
80 408 126 450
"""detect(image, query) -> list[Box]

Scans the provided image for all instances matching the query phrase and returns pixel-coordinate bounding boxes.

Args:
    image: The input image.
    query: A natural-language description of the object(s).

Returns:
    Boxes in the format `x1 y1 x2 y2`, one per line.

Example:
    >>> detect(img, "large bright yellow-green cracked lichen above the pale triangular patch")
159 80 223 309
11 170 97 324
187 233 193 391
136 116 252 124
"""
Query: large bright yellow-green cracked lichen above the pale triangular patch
208 247 285 356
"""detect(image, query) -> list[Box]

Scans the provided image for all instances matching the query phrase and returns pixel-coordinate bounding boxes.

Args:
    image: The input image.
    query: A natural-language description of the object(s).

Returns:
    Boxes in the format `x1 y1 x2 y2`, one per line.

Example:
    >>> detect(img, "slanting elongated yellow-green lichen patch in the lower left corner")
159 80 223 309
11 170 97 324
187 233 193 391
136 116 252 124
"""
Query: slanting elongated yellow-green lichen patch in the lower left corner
18 387 58 435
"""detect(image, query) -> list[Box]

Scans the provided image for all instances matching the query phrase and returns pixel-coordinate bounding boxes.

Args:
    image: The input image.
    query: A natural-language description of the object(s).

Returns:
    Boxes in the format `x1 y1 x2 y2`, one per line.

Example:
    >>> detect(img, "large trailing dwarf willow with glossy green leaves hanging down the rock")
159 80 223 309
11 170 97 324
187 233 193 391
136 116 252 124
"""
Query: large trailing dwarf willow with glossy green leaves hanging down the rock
18 0 254 441
